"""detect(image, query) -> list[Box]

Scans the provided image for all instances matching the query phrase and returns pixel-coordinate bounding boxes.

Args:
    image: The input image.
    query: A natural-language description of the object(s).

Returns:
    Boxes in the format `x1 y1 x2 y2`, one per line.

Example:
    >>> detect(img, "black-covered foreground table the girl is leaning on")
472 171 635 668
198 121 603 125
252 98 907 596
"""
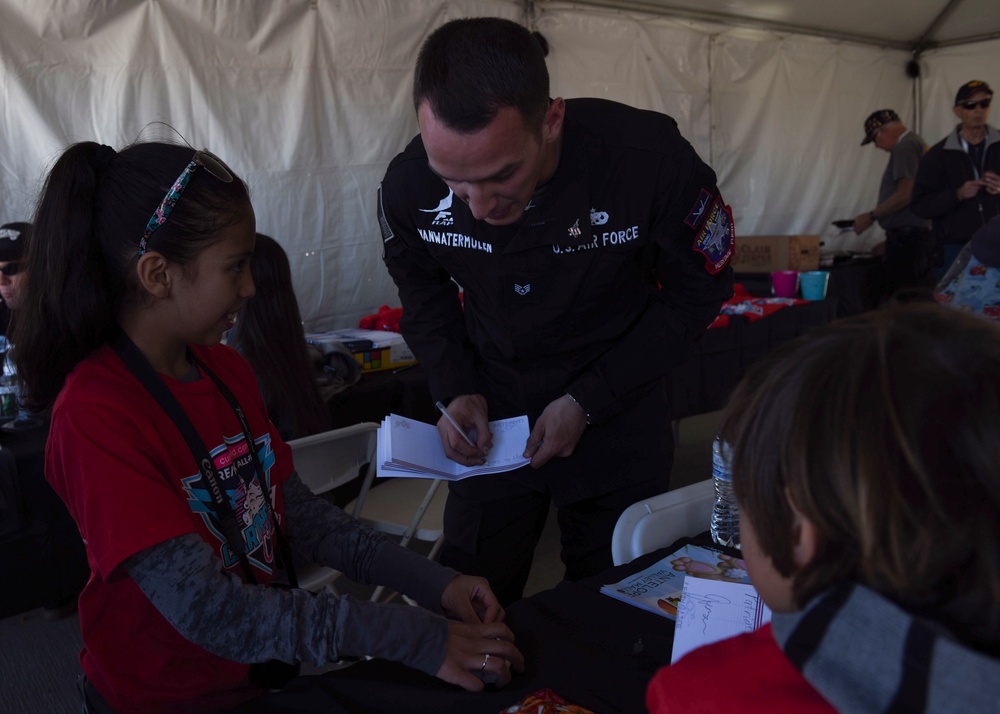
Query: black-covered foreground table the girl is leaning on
237 532 728 714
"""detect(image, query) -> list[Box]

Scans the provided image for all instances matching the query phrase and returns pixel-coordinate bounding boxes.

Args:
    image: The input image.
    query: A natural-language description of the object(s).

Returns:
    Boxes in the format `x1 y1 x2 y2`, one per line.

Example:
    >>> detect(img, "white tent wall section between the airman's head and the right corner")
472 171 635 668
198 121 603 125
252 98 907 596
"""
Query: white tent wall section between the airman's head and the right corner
537 3 914 235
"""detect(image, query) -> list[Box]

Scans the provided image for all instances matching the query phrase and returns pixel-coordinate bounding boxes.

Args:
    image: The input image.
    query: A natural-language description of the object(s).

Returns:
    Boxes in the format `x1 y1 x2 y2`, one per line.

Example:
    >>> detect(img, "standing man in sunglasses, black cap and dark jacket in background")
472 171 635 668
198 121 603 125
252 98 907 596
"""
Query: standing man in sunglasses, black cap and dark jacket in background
910 79 1000 279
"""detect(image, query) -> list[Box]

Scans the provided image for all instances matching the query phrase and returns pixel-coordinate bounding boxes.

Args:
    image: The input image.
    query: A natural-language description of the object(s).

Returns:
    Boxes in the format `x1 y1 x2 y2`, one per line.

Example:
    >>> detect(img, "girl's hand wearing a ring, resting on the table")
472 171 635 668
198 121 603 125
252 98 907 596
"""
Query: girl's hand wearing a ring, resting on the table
437 621 524 692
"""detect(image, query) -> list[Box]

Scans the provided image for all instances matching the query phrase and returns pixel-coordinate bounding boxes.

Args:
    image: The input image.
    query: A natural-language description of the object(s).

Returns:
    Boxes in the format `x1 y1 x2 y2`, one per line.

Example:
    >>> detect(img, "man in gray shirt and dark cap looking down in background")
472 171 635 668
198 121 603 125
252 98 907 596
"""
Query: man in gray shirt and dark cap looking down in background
854 109 931 296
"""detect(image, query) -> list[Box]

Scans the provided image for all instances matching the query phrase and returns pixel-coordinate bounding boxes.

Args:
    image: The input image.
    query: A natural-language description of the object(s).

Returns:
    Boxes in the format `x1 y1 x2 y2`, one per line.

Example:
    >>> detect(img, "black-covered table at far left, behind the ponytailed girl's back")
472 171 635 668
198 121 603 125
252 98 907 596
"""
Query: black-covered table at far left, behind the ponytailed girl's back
0 422 90 618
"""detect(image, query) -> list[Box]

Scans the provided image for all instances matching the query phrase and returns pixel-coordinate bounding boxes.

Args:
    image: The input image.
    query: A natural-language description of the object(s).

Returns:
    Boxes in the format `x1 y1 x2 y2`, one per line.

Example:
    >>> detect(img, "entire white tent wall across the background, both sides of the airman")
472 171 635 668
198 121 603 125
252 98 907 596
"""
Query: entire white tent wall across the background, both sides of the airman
0 0 998 330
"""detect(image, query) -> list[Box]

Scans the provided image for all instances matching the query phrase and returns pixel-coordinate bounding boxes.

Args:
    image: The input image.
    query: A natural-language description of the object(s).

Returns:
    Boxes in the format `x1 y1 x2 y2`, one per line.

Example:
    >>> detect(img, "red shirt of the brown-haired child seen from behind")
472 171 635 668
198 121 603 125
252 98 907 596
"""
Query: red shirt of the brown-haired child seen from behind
646 624 836 714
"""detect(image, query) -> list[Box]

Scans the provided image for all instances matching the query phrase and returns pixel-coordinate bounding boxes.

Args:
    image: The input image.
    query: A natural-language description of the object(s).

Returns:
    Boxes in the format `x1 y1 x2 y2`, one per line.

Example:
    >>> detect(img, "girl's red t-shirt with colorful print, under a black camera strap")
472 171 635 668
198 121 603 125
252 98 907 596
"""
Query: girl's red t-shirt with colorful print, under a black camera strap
45 345 292 712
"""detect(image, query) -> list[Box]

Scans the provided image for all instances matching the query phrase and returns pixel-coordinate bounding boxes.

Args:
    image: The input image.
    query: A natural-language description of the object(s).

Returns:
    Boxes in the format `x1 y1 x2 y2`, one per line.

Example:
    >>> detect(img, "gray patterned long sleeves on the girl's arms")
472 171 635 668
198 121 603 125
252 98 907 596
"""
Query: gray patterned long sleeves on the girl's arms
125 473 458 675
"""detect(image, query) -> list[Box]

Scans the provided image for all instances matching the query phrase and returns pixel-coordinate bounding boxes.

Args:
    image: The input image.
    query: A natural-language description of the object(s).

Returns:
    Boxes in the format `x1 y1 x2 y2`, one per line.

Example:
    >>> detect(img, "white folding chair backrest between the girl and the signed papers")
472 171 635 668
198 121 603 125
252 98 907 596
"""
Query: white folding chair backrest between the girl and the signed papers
288 422 379 512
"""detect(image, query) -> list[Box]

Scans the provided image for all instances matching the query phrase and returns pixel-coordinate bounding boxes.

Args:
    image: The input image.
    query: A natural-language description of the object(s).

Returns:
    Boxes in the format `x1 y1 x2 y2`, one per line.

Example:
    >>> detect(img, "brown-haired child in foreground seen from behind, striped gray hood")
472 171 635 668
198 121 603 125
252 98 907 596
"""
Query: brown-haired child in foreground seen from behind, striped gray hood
647 304 1000 714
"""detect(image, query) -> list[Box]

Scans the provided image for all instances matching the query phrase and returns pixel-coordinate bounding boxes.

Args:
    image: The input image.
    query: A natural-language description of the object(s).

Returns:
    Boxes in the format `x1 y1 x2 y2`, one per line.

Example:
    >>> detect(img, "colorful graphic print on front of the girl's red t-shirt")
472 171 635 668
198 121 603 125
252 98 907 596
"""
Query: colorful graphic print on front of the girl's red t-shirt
181 433 275 574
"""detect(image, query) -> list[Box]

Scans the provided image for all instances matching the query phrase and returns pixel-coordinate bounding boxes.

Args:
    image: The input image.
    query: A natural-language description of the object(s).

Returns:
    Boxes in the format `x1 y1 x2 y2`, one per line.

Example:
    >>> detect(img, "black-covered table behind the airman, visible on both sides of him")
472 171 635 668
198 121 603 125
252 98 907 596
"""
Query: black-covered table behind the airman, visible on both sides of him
327 297 838 428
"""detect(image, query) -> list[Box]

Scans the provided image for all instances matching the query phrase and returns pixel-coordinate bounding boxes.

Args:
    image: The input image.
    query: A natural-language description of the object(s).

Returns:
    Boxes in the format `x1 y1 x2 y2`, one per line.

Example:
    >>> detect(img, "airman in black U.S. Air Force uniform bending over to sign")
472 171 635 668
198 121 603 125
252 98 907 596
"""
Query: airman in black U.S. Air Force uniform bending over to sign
378 18 734 603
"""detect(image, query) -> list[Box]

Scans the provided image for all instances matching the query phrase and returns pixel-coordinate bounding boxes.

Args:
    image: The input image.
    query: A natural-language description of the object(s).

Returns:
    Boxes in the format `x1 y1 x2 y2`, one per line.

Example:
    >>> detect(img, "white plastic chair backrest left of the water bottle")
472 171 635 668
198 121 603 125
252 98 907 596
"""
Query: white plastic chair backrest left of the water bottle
611 479 715 565
